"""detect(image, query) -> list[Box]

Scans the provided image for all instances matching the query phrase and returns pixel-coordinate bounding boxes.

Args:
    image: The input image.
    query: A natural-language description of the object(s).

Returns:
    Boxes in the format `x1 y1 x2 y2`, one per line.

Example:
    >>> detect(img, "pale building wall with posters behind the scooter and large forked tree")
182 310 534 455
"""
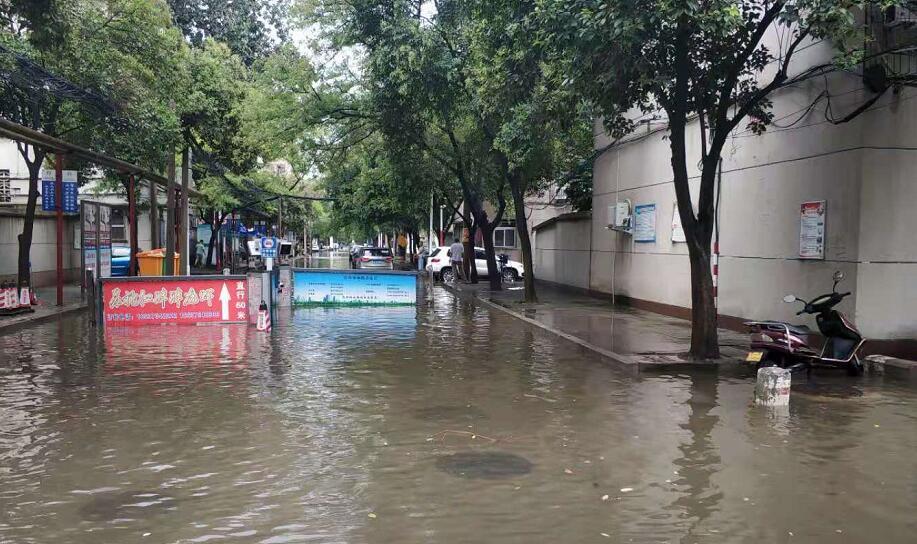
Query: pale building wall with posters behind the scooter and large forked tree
584 34 917 339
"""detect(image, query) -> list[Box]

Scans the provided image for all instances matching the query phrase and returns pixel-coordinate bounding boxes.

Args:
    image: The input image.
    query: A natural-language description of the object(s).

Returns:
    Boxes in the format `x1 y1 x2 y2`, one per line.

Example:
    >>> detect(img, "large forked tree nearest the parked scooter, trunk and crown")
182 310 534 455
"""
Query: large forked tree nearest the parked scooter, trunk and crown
538 0 890 358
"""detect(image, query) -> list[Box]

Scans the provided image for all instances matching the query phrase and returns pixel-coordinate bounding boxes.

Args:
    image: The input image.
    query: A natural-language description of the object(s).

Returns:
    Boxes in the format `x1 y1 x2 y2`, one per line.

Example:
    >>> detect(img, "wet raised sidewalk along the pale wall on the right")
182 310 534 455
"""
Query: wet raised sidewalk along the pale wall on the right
445 282 748 369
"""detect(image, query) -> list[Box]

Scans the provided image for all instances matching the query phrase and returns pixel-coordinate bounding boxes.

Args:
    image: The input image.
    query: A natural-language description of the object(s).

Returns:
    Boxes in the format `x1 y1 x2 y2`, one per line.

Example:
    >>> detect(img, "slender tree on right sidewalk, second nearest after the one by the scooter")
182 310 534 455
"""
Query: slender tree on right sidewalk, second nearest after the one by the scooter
466 0 592 302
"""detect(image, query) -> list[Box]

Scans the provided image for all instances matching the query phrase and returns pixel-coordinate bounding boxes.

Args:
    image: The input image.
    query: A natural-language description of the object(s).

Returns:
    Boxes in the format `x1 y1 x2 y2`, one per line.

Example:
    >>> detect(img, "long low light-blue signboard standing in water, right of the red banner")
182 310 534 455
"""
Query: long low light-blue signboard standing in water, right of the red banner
293 269 417 306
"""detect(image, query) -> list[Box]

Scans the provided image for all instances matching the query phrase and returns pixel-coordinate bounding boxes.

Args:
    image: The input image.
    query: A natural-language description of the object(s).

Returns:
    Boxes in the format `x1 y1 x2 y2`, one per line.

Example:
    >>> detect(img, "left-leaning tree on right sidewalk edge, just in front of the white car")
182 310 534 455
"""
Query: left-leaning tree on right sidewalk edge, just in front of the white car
319 0 506 289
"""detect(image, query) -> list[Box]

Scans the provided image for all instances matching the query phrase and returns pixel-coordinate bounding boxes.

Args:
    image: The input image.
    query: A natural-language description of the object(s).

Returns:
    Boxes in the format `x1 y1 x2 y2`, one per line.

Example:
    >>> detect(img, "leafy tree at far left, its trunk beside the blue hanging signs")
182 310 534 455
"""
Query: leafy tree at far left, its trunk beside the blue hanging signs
0 0 182 286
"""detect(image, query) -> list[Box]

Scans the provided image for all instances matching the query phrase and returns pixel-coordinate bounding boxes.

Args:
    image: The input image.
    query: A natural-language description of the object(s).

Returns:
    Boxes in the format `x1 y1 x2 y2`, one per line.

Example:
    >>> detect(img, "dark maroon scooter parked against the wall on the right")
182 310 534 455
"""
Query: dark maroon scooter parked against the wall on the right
745 270 866 376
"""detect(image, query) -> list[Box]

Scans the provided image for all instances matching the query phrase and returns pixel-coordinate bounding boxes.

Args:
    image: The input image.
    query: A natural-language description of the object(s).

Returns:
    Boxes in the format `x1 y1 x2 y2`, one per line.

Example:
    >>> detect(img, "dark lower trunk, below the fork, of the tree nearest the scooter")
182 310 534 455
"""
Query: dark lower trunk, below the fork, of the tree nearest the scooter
688 238 720 359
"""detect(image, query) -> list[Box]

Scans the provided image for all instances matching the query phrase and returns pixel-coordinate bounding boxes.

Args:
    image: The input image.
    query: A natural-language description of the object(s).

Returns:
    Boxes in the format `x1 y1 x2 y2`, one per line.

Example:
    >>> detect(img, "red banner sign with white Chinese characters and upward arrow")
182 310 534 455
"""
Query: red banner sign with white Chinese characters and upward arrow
102 276 248 325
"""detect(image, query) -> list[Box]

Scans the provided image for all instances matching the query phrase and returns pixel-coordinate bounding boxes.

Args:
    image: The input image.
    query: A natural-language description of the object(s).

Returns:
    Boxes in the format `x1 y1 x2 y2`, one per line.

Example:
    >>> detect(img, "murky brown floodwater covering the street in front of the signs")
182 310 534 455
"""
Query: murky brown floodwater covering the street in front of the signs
0 290 917 544
